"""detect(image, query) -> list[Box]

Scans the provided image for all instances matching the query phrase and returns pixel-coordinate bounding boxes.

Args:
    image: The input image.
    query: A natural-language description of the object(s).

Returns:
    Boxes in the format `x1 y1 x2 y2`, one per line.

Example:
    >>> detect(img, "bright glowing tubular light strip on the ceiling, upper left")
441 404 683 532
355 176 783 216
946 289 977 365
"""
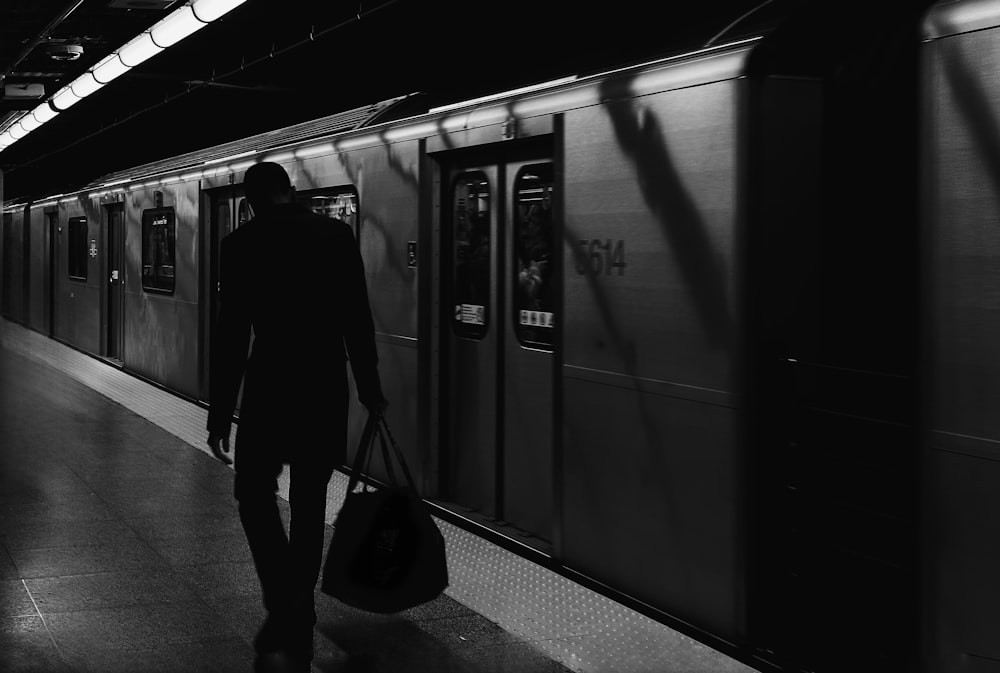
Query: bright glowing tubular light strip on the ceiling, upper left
0 0 246 152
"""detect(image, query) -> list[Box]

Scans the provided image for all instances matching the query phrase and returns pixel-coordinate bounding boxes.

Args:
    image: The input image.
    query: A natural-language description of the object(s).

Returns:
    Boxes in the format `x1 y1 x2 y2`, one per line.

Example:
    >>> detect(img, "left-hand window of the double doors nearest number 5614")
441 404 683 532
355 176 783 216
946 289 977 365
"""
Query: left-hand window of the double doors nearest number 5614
451 171 492 339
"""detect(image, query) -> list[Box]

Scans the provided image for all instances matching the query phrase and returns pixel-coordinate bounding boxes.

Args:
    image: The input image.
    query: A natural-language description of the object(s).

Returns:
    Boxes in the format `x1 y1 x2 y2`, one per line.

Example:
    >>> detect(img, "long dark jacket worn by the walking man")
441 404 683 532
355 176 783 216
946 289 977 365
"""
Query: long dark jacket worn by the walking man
208 204 382 456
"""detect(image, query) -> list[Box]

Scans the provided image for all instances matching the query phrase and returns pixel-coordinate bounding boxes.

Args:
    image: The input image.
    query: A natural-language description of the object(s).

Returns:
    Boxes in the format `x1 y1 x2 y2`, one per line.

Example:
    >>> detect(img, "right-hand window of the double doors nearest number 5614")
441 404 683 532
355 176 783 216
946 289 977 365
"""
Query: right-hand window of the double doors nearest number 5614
511 163 555 349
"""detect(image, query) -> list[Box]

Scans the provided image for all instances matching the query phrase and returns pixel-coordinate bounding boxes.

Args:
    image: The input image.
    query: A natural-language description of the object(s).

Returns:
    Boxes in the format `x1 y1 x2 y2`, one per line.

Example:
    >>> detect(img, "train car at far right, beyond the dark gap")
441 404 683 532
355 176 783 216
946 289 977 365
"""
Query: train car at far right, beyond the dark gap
922 1 1000 673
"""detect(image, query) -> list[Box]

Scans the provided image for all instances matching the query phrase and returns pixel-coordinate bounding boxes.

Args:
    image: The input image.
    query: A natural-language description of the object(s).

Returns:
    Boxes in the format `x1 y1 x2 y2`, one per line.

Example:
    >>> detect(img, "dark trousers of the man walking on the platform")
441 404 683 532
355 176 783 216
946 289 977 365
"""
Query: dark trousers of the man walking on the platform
235 384 347 656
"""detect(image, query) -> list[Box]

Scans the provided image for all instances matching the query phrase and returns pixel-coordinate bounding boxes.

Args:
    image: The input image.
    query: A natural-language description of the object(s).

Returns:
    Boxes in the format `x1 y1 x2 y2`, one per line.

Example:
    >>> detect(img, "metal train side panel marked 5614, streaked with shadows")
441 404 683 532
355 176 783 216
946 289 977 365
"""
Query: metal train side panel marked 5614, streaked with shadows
562 80 744 637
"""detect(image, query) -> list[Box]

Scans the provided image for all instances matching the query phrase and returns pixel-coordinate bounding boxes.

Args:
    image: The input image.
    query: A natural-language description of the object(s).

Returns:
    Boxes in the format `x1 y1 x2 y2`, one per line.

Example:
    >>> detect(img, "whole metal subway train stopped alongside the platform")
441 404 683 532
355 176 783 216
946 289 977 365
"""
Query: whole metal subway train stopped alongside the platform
0 0 1000 673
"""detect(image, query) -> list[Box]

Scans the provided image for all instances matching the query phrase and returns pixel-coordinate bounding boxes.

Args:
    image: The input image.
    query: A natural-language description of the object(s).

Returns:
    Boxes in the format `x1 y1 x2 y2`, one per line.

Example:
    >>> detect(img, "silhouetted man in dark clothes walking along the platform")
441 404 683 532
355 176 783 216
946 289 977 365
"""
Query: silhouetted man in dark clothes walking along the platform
208 162 386 670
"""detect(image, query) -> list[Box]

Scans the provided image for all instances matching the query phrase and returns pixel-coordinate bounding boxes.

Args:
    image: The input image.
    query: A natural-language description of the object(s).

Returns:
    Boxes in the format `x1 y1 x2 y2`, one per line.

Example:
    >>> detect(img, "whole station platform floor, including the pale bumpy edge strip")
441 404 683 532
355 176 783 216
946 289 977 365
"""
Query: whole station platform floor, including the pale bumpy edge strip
0 319 754 673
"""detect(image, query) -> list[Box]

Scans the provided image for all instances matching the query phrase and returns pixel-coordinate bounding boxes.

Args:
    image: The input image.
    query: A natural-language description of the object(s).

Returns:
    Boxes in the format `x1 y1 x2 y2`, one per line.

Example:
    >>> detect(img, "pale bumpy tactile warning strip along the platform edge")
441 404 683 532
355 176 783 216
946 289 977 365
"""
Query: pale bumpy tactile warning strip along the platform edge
0 319 754 673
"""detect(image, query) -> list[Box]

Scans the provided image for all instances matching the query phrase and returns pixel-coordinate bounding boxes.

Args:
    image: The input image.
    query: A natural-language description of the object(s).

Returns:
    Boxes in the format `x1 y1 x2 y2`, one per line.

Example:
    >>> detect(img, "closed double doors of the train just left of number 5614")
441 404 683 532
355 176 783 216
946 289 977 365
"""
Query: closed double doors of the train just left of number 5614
441 159 558 541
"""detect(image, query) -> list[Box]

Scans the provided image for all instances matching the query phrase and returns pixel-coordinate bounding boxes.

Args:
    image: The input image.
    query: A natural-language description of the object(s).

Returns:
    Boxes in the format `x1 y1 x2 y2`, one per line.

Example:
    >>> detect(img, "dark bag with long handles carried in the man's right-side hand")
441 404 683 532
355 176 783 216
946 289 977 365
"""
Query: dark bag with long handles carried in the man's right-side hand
320 415 448 613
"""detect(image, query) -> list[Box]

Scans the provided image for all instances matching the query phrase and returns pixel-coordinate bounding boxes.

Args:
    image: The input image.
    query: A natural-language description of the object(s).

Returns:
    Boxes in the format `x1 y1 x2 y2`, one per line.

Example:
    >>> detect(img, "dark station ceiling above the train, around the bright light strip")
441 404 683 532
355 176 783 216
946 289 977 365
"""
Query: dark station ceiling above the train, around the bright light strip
0 0 788 200
